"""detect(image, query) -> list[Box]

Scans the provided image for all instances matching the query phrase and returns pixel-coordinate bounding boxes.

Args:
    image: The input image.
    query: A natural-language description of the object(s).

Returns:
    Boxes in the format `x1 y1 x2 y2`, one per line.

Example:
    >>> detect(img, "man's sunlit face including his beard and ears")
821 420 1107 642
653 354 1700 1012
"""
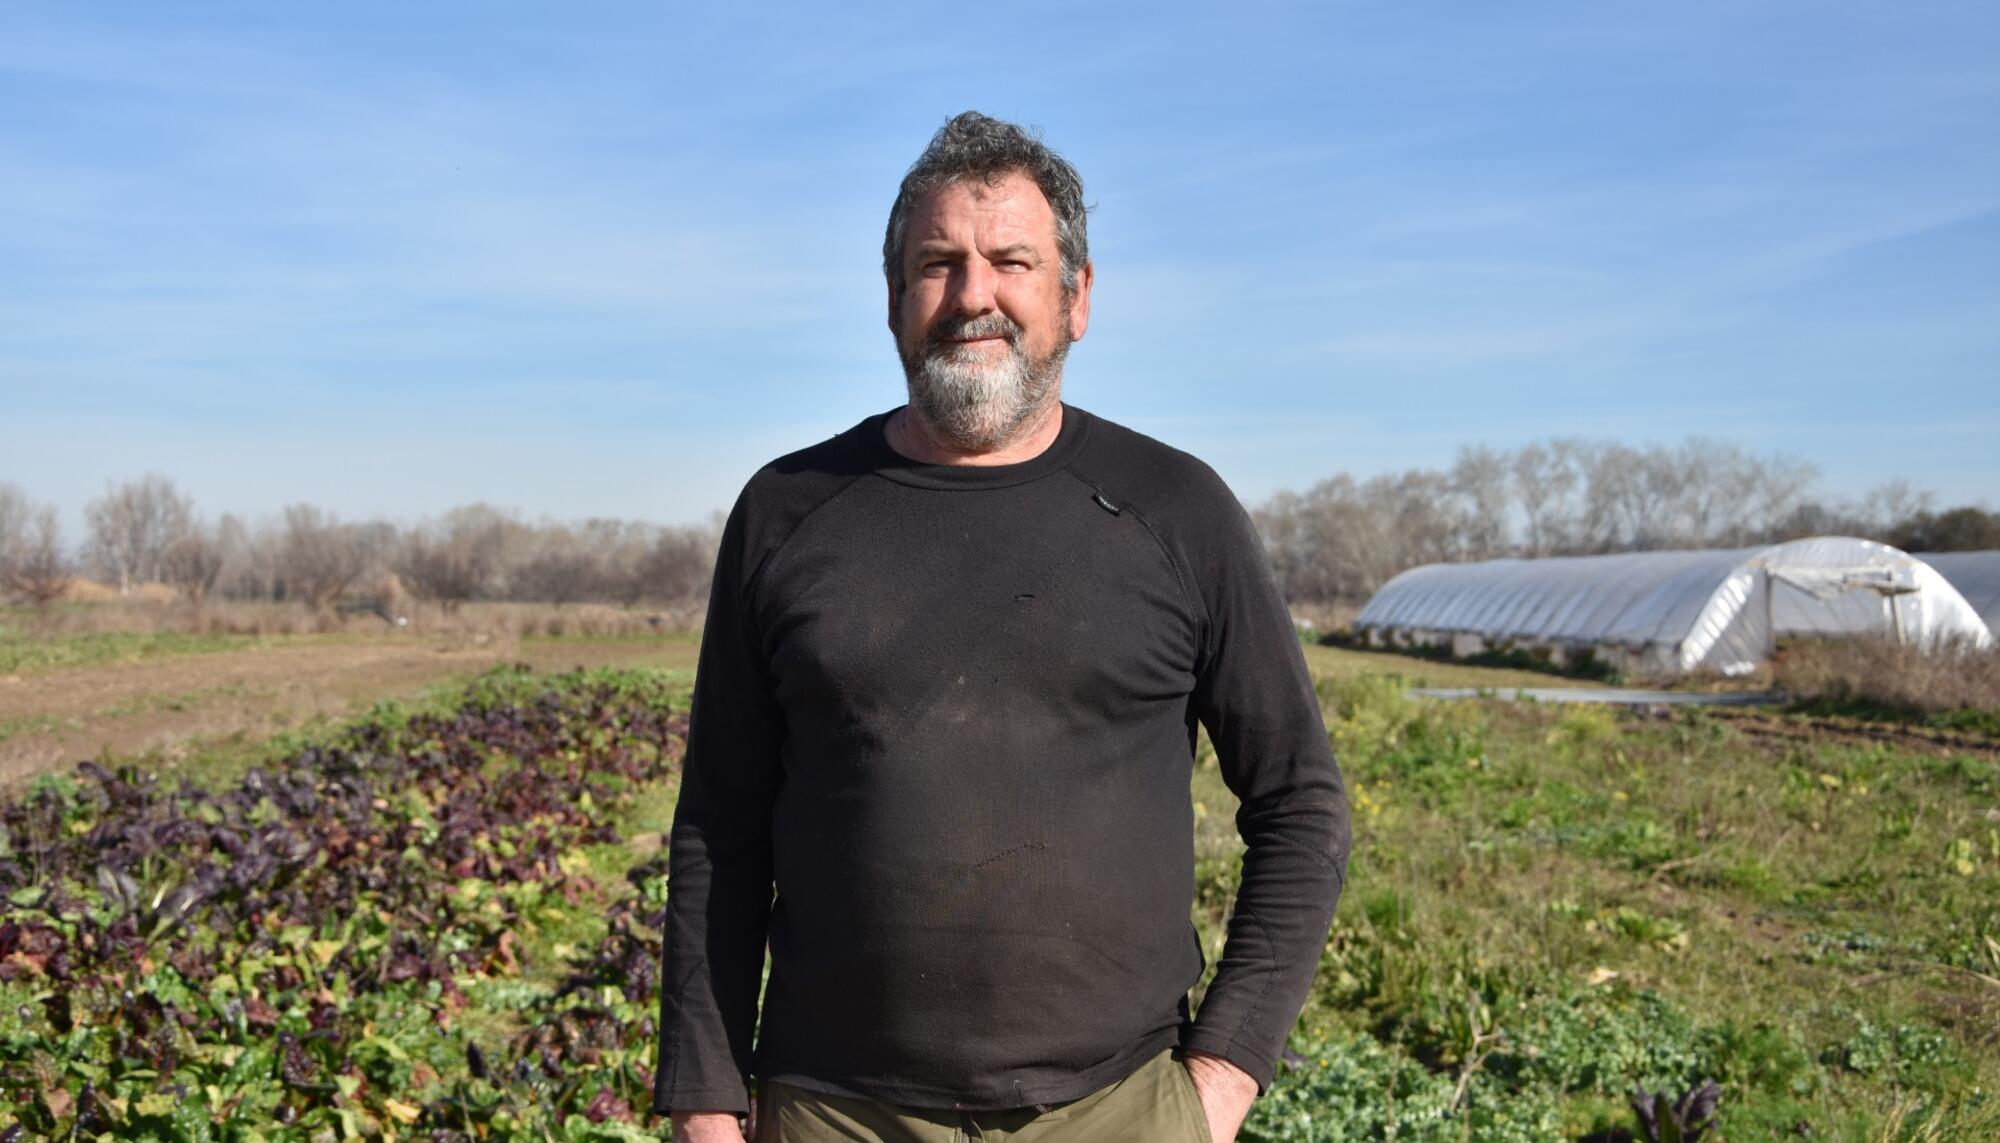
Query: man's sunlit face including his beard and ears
888 174 1092 450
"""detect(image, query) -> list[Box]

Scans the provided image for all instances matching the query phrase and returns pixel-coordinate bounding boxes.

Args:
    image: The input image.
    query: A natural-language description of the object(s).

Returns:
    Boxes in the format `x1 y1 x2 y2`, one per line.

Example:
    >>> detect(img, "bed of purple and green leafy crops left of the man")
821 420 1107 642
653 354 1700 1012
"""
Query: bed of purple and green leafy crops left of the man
0 671 684 1139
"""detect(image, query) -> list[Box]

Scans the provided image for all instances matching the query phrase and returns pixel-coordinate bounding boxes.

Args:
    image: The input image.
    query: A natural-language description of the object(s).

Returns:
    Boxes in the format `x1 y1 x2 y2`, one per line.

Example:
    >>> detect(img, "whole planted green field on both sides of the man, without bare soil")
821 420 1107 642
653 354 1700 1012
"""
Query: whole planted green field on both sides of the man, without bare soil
0 643 2000 1143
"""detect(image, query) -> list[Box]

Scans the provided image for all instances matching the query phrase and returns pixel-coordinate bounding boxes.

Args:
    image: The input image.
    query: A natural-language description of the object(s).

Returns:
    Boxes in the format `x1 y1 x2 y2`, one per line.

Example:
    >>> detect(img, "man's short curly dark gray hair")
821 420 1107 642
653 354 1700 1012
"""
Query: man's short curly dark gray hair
882 112 1090 296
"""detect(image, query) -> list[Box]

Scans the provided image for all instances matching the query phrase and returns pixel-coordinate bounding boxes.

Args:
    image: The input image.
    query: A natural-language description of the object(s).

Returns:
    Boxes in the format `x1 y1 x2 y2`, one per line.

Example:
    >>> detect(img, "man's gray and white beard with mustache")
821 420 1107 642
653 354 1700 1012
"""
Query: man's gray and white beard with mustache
898 314 1070 452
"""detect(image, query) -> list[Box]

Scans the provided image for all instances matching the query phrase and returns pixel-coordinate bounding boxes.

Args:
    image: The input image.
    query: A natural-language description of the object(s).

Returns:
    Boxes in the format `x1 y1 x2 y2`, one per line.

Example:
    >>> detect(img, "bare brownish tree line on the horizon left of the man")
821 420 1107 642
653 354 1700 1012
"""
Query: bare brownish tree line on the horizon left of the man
0 474 720 611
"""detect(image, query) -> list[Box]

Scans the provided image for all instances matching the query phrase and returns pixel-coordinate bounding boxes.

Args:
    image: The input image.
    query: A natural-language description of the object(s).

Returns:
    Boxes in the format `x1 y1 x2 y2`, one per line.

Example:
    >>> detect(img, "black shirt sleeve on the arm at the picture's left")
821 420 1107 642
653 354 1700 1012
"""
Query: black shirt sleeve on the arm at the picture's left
652 494 784 1115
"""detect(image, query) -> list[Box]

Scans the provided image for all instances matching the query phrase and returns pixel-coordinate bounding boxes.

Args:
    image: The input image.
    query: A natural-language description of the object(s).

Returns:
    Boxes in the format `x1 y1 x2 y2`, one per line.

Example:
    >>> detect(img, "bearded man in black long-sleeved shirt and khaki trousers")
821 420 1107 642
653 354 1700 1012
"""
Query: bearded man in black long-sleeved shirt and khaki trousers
654 112 1348 1143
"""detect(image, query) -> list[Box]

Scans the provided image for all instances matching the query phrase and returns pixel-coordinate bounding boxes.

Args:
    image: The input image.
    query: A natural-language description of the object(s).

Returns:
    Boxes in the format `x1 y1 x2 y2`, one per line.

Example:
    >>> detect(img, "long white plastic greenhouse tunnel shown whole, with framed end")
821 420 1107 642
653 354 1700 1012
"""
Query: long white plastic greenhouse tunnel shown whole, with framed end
1354 536 1994 677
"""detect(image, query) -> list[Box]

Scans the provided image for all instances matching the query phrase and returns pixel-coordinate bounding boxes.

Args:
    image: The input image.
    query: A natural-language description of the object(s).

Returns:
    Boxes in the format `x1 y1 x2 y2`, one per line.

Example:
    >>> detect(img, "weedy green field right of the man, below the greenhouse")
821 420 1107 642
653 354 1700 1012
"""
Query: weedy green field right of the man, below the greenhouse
1194 663 2000 1143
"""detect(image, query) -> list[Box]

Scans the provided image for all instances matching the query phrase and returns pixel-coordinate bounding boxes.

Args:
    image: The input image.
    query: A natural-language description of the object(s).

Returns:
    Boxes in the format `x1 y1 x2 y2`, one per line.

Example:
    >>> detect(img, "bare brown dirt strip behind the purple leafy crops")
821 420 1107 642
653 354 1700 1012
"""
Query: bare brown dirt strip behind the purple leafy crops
0 635 696 787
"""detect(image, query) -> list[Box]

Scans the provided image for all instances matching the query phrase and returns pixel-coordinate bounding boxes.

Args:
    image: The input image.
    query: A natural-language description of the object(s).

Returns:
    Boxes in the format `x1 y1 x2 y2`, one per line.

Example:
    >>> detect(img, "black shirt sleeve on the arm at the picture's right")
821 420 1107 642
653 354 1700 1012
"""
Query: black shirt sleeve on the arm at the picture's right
1184 483 1350 1091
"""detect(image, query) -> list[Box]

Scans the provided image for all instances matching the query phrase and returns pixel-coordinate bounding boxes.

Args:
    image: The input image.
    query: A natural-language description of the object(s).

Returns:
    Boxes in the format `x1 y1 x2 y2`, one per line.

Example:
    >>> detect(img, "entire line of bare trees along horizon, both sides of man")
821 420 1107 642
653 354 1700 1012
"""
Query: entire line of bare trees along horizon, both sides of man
0 438 2000 609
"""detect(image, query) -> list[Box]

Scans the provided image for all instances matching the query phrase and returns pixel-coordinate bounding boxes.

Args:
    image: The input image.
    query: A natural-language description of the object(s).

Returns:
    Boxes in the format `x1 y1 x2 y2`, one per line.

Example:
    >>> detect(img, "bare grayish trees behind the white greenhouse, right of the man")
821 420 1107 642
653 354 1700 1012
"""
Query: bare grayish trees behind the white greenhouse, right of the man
1252 438 2000 603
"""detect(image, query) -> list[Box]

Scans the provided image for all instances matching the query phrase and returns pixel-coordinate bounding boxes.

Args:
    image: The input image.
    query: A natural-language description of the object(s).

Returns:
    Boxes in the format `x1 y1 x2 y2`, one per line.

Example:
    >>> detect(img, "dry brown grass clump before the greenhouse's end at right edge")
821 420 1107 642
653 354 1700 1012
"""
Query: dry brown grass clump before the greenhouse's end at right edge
1774 639 2000 715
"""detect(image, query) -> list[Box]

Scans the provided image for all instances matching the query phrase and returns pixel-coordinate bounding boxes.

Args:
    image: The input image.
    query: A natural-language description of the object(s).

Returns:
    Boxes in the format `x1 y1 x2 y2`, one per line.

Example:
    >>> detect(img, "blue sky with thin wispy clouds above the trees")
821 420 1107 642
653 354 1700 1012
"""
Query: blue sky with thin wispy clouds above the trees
0 0 2000 528
